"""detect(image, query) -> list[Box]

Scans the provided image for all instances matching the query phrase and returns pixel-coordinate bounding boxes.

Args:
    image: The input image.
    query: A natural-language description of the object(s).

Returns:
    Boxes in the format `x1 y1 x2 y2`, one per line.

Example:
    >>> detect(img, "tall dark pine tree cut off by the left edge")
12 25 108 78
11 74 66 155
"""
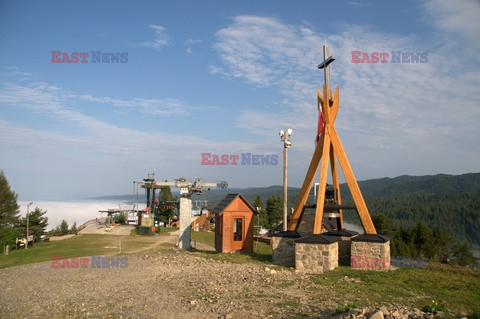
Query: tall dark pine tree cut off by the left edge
0 170 21 246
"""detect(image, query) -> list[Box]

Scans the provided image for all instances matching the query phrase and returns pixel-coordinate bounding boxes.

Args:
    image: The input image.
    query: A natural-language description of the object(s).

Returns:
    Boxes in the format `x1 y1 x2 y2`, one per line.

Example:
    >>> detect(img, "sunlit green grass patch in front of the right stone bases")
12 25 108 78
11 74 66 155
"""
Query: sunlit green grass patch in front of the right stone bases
312 263 480 312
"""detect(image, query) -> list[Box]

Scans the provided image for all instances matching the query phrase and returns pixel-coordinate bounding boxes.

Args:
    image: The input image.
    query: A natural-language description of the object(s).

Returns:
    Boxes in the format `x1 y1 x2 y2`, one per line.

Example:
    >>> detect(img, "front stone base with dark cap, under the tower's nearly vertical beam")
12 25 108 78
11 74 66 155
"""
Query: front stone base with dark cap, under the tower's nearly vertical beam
295 235 338 274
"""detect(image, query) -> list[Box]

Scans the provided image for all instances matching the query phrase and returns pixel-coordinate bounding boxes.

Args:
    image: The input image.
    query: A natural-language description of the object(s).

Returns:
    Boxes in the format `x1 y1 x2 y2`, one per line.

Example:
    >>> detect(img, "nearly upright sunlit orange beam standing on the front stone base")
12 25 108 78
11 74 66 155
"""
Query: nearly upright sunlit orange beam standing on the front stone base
313 132 330 234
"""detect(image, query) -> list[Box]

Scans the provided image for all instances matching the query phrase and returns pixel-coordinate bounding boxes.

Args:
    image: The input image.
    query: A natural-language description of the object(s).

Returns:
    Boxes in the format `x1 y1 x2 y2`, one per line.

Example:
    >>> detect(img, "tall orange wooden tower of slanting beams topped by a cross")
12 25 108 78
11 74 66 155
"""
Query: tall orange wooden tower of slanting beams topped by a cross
288 44 377 234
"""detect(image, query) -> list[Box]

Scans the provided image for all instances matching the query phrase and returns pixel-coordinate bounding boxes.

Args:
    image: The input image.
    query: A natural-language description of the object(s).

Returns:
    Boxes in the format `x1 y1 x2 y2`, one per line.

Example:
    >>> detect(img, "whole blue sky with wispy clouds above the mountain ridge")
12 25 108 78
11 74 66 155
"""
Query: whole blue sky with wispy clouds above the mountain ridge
0 0 480 200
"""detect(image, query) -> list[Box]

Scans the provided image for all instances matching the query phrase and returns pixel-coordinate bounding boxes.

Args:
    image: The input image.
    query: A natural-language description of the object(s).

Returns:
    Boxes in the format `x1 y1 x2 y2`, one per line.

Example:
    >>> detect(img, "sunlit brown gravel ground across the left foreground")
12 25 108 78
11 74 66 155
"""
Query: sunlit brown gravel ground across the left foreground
0 236 464 319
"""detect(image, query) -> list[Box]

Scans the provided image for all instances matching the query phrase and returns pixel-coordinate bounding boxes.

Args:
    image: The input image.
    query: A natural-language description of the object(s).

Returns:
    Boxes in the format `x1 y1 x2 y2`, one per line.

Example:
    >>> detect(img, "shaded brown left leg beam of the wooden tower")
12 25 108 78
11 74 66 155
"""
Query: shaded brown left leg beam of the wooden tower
287 134 323 231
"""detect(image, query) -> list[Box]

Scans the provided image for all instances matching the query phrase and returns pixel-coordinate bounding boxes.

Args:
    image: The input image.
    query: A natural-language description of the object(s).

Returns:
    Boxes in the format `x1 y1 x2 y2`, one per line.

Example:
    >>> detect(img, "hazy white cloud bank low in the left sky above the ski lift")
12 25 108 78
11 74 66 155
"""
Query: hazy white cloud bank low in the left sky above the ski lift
0 75 282 199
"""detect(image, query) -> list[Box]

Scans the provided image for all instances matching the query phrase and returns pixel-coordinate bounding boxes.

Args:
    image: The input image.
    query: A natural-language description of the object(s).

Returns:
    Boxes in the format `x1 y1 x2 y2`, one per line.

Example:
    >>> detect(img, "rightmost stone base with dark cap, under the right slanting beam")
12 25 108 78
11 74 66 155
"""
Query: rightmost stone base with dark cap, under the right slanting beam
351 234 390 270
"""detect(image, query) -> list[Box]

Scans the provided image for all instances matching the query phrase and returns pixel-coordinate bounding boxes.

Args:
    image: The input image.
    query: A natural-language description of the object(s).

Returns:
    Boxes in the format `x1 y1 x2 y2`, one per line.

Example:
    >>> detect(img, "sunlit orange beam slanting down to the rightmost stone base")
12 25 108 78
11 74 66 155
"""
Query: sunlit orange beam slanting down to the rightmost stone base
330 125 377 234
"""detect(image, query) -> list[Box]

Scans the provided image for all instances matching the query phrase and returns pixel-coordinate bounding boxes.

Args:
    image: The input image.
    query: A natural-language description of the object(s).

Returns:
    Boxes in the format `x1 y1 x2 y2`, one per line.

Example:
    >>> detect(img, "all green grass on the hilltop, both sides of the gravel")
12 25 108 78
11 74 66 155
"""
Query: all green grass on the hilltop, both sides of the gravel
0 229 480 318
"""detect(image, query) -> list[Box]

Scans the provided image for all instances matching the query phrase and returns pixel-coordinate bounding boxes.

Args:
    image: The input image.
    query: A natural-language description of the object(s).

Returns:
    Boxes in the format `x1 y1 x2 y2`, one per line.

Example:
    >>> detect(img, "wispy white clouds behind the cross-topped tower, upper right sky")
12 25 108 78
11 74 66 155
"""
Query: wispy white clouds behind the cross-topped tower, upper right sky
211 5 480 177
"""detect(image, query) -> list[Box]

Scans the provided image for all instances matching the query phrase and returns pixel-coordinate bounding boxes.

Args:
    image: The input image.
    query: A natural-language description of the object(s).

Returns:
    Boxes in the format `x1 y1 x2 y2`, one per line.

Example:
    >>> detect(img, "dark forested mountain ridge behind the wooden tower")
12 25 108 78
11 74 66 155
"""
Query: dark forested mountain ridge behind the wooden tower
90 173 480 246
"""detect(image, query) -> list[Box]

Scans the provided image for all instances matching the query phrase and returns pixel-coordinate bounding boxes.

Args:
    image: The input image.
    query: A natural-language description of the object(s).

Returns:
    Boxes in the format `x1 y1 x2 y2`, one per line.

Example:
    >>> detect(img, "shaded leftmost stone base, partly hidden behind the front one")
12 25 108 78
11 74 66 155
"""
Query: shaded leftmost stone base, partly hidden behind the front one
272 231 301 267
